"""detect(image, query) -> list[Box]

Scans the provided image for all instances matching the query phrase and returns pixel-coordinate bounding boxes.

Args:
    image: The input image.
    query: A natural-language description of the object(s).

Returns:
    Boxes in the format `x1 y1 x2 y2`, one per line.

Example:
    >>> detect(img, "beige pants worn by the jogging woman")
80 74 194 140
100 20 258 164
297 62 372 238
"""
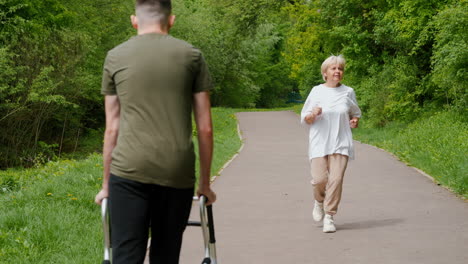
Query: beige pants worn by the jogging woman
310 154 348 215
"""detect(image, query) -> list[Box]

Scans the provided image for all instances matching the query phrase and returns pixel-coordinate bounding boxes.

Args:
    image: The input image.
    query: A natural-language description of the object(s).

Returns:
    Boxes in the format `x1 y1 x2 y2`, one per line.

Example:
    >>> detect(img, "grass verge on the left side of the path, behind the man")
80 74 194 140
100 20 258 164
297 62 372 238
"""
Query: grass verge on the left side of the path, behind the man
0 108 241 264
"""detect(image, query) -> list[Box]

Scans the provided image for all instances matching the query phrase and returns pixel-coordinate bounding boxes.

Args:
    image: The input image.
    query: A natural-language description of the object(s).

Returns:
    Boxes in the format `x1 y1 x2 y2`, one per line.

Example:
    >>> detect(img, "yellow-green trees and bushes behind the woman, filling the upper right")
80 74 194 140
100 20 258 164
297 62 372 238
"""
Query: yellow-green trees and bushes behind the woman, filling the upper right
285 0 468 126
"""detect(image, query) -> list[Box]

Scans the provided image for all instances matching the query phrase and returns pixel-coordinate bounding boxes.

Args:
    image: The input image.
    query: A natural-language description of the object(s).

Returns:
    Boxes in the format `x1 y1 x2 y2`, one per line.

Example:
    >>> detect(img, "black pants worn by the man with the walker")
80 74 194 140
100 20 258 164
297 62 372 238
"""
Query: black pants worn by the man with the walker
109 175 193 264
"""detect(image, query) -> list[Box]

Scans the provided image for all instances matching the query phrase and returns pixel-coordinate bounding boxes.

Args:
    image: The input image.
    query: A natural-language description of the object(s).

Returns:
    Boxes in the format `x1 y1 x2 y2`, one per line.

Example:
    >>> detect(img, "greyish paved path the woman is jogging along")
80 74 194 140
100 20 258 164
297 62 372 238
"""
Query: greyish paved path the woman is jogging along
181 112 468 264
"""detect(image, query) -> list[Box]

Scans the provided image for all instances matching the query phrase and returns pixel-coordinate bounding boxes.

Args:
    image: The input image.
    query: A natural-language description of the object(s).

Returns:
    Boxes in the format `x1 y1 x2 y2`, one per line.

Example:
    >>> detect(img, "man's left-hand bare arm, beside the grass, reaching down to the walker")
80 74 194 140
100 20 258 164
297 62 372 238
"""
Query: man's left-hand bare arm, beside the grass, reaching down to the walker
95 95 120 204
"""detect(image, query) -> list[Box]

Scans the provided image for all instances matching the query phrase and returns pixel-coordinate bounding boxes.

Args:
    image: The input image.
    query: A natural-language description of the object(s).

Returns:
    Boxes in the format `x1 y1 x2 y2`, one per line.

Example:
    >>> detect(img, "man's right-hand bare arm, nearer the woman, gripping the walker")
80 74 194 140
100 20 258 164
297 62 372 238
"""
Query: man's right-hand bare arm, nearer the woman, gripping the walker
193 91 216 205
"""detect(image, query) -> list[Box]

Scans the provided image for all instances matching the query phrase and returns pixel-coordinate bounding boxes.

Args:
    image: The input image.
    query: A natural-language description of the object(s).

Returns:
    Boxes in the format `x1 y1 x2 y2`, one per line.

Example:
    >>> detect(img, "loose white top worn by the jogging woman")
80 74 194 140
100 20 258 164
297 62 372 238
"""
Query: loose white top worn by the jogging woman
301 84 361 159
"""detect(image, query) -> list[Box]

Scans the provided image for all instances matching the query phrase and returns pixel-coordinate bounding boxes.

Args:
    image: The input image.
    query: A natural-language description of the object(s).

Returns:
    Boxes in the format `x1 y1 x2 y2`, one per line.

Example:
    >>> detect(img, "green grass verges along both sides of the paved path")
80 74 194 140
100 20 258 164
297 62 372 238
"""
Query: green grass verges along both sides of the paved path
0 105 468 264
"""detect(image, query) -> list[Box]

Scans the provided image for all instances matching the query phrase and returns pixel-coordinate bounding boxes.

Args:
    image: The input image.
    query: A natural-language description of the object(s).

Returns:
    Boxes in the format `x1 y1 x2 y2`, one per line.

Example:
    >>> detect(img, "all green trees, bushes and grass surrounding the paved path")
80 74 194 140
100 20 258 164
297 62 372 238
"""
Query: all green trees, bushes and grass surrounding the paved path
0 0 468 263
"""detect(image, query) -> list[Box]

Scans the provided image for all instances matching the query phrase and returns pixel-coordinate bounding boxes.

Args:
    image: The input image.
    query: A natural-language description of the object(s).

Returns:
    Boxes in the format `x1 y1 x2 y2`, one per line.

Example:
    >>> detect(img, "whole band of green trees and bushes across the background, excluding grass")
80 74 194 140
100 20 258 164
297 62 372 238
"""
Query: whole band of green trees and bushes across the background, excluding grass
0 0 468 168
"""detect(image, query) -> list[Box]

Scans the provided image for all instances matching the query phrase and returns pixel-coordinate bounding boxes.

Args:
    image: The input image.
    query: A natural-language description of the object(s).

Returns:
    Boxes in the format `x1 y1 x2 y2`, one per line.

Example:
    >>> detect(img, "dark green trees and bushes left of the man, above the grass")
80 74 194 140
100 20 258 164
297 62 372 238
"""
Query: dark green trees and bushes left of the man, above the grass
0 0 133 168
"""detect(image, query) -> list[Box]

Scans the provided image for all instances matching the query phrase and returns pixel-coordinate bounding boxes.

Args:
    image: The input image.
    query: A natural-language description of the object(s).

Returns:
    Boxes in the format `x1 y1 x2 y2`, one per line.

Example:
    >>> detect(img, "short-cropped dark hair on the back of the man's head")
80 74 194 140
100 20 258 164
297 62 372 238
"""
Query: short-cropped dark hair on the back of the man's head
135 0 172 26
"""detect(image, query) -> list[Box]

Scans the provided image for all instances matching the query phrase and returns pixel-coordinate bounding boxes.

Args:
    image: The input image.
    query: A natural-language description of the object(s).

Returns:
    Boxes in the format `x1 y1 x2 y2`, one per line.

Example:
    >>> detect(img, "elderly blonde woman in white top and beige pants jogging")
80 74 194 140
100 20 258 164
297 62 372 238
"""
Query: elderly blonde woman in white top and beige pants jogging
301 55 361 233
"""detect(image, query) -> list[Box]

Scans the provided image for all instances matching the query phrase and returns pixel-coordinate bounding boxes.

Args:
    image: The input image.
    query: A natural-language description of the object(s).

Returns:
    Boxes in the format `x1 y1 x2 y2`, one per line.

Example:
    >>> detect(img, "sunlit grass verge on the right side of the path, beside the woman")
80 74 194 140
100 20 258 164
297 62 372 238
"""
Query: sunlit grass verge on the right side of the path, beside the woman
292 105 468 199
